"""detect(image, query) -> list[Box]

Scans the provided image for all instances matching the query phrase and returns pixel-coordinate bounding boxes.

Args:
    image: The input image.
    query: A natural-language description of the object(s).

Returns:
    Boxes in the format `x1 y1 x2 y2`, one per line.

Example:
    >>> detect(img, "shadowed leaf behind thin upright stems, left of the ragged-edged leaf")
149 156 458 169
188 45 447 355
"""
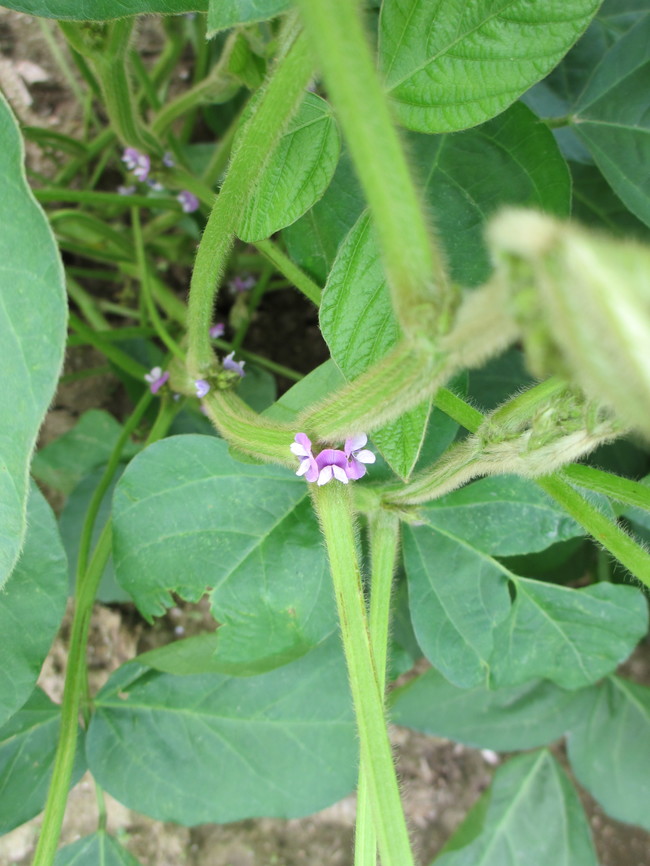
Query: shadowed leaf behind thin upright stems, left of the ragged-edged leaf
59 467 131 604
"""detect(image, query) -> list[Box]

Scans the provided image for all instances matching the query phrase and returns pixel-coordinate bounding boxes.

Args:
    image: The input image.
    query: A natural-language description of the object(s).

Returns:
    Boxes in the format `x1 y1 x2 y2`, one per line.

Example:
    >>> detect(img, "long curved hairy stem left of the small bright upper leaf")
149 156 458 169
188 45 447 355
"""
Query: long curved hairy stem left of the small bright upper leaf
188 15 312 379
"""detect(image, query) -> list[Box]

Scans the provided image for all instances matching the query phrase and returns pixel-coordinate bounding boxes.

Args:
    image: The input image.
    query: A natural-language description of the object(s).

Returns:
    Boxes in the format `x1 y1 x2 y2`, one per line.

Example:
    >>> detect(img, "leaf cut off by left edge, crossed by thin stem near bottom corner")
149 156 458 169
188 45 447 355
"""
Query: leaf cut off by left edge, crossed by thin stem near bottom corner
0 689 86 834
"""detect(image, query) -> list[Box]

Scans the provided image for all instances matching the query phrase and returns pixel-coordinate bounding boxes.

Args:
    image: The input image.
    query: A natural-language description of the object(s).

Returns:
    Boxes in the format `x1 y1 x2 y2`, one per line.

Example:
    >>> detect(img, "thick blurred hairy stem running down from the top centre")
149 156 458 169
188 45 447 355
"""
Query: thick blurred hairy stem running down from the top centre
298 0 451 339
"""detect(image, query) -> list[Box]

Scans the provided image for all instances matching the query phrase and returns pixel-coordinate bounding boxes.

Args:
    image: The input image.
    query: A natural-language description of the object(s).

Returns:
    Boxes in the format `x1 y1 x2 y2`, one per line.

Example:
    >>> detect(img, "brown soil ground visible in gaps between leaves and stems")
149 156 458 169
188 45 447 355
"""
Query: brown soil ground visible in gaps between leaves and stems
0 10 650 866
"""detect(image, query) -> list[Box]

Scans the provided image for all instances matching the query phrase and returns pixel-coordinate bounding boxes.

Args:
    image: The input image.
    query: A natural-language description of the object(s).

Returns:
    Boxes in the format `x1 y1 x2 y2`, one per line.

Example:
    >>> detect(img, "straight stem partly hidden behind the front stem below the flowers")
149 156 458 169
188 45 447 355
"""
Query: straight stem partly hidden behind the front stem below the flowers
354 510 399 866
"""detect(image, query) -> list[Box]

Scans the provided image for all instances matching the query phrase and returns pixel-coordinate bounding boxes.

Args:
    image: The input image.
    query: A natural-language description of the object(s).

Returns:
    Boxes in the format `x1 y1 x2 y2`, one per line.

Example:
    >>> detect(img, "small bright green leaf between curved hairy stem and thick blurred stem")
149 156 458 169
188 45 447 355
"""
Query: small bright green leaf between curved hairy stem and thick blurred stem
234 93 340 242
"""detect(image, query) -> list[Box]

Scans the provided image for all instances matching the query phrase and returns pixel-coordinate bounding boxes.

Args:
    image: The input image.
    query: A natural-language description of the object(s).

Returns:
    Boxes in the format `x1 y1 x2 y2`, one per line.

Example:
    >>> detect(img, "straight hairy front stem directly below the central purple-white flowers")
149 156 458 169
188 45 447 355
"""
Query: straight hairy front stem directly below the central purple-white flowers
312 483 414 866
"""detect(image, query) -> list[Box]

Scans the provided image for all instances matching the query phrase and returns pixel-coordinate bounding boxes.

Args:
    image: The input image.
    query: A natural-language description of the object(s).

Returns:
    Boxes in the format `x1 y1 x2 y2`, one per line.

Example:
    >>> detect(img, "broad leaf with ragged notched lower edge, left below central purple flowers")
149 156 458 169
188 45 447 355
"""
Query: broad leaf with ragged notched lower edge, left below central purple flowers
113 436 336 674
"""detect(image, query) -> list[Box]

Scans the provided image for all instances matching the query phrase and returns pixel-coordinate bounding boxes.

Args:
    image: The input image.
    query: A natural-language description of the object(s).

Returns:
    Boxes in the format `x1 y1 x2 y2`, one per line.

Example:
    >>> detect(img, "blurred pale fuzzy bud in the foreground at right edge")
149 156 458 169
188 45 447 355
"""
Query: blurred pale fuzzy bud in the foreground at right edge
488 210 650 434
